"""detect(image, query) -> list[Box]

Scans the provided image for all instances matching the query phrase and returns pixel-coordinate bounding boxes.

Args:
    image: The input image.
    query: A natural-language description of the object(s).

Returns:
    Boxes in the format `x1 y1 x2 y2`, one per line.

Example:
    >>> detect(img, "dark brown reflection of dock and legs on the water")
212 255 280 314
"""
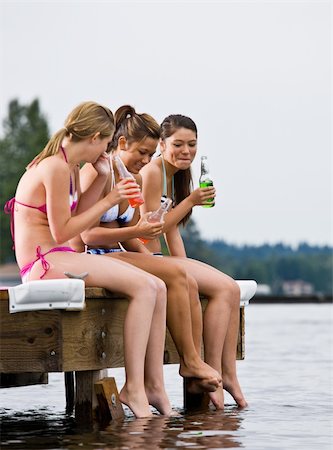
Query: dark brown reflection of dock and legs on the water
1 407 242 450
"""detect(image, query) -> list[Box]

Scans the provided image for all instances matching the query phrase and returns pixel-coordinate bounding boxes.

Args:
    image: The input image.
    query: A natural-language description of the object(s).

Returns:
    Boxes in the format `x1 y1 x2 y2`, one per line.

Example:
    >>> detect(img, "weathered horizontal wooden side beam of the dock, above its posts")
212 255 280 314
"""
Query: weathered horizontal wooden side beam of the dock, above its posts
0 288 245 373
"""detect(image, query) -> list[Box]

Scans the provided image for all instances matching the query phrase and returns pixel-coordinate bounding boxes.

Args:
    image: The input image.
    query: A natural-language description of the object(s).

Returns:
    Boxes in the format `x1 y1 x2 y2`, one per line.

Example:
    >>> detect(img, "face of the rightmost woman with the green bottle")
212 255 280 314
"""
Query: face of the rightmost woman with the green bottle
161 128 197 170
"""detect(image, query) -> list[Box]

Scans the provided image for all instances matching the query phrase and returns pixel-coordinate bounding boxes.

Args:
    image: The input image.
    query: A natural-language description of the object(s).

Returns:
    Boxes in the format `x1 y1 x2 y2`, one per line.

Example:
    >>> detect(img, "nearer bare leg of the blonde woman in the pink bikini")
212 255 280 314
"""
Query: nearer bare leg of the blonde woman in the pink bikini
30 252 162 417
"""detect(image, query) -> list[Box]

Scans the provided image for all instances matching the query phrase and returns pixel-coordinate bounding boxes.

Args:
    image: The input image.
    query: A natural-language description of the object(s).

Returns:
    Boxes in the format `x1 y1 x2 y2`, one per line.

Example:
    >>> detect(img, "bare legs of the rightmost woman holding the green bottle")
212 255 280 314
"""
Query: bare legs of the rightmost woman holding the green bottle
164 257 247 409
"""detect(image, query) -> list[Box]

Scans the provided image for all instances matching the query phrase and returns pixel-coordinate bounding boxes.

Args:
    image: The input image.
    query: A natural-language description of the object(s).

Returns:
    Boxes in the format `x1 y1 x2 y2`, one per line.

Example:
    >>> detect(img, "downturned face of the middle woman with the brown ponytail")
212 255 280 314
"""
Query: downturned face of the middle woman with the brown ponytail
120 137 158 174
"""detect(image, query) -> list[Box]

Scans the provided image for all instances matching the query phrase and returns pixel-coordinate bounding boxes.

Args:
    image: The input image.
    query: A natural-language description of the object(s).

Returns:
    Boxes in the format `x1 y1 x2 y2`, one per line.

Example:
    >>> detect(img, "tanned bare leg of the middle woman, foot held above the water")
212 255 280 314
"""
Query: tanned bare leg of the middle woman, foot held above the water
110 252 221 391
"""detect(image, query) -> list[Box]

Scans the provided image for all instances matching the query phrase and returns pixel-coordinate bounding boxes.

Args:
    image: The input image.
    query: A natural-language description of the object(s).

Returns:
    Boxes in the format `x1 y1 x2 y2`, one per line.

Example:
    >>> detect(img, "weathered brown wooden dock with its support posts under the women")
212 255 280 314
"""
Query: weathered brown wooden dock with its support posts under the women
0 287 245 423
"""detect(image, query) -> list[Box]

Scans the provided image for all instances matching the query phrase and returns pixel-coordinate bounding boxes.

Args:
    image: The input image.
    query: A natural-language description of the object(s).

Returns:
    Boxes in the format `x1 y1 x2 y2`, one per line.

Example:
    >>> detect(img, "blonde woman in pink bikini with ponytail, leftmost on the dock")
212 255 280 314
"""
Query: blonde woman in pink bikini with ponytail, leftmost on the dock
6 102 171 417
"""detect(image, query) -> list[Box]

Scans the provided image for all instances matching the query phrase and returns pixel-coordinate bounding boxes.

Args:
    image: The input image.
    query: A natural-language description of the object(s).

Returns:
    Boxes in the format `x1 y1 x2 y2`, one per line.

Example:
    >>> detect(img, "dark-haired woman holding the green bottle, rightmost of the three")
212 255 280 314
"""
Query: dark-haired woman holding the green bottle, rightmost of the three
140 114 247 409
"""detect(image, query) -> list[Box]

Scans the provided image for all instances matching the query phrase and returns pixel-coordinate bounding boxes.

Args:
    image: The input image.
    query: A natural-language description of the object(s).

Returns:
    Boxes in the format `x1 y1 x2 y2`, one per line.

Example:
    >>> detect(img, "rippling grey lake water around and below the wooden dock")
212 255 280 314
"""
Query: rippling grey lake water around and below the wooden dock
0 303 333 450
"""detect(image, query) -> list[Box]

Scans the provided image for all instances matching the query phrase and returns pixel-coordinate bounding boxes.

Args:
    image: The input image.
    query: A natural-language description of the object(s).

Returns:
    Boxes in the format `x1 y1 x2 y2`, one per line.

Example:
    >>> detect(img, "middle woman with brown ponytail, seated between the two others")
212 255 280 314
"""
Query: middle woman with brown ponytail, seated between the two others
81 105 221 412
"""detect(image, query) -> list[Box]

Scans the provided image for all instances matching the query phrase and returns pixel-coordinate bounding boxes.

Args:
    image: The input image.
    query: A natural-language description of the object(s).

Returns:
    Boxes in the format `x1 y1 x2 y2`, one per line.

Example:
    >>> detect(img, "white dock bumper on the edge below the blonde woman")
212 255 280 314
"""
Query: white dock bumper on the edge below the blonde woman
8 278 85 313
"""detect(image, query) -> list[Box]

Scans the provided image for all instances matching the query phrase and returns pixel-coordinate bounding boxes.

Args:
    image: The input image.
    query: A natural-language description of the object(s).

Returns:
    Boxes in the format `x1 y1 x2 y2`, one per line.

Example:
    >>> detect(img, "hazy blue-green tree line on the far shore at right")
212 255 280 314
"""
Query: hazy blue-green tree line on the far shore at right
182 220 333 295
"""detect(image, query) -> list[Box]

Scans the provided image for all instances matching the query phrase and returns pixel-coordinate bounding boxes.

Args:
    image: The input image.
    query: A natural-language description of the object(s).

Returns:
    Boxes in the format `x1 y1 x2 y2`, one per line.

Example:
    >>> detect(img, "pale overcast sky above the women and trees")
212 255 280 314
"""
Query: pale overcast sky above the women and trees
0 0 333 246
